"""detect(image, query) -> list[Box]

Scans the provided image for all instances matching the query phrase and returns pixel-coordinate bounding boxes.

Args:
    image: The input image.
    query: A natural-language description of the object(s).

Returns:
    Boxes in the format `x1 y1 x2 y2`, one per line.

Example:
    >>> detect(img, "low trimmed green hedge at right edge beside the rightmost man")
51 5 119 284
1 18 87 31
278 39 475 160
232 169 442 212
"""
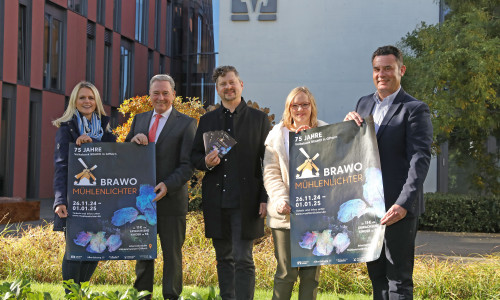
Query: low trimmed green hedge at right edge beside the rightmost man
419 193 500 233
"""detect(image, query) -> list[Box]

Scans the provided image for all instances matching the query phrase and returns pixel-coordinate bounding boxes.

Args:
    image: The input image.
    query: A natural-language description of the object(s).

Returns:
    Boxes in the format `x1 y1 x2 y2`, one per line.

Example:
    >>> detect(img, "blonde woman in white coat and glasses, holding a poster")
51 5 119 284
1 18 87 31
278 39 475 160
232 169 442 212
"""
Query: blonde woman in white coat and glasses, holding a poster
264 87 327 300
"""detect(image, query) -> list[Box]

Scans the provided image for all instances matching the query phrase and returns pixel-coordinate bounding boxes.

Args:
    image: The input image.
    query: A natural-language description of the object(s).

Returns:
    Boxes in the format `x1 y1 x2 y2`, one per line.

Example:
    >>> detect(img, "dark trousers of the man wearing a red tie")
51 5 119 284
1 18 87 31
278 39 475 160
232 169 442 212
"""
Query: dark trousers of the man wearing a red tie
134 216 186 299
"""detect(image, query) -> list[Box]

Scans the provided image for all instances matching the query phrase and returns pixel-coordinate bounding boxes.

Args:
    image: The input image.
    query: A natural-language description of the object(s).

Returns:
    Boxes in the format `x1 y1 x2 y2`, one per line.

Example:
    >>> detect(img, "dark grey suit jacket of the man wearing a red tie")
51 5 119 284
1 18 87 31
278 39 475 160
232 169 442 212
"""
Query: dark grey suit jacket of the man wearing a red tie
125 108 196 216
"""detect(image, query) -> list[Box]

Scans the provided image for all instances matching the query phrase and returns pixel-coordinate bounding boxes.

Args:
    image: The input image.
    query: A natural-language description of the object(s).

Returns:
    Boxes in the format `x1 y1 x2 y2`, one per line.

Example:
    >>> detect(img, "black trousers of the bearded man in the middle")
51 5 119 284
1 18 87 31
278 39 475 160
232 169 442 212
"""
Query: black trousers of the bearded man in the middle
212 208 255 300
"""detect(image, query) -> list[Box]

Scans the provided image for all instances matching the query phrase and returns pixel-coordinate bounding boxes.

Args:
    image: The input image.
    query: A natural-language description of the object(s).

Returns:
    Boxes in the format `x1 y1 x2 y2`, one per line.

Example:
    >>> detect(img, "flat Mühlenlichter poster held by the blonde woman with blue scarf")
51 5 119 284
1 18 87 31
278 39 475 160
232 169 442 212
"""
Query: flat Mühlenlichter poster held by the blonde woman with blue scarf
66 143 156 260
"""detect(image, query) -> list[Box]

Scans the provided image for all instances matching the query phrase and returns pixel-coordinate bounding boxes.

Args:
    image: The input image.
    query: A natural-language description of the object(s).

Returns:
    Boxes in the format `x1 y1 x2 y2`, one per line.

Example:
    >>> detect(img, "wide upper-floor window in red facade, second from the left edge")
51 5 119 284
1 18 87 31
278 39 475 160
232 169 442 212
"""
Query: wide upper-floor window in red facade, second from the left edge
43 6 64 90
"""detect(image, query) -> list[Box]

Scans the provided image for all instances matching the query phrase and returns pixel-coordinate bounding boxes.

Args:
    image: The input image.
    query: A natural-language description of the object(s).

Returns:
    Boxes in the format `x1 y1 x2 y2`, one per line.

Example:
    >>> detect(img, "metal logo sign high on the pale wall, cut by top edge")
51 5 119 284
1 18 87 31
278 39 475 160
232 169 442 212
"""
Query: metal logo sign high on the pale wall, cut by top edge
231 0 278 21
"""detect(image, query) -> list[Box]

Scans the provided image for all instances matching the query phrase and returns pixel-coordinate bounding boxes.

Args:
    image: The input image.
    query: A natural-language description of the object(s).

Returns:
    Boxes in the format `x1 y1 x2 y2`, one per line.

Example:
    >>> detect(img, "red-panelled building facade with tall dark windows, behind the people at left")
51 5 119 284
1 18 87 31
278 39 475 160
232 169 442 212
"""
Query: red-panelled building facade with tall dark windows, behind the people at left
0 0 215 198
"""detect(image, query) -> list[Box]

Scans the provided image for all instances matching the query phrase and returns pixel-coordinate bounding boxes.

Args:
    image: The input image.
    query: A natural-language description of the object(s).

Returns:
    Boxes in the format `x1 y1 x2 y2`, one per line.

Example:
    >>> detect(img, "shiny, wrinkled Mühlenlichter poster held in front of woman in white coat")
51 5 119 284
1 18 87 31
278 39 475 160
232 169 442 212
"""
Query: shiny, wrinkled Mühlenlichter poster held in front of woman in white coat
290 116 385 267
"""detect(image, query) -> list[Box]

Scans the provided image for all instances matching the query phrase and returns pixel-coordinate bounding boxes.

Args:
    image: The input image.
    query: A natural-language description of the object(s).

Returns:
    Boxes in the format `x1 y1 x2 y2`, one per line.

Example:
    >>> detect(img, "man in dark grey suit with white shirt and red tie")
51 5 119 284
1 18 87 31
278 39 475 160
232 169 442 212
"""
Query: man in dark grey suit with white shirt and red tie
125 74 196 299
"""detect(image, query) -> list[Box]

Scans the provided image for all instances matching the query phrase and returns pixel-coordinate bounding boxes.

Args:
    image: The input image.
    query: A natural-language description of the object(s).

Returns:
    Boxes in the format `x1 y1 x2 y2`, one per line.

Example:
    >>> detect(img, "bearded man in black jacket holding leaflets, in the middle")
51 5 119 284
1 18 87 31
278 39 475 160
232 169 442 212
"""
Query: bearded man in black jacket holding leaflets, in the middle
191 66 271 300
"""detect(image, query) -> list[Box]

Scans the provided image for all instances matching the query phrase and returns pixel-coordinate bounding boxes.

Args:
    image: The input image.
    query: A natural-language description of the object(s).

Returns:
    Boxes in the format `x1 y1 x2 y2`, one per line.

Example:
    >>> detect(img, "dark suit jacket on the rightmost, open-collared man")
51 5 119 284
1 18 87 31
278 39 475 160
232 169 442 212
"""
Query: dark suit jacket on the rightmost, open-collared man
356 88 432 216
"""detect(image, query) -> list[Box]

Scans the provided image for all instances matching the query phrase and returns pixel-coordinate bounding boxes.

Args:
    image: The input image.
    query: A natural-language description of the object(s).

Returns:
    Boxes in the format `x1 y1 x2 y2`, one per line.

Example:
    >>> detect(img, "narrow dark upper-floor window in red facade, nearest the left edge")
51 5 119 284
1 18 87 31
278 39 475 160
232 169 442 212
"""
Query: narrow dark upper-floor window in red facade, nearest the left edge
17 0 31 84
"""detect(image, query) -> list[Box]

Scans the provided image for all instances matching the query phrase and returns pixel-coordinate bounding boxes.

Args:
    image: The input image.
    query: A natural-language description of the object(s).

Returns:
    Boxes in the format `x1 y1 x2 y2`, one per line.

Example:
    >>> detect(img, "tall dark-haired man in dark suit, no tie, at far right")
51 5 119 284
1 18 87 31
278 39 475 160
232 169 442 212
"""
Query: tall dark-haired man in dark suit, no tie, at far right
344 46 432 299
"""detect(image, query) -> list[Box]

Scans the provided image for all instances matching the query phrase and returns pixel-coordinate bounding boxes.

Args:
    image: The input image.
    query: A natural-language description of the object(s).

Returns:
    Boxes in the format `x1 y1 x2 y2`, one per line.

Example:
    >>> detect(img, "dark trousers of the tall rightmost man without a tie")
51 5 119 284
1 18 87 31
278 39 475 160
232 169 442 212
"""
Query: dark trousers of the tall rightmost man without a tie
366 215 418 300
